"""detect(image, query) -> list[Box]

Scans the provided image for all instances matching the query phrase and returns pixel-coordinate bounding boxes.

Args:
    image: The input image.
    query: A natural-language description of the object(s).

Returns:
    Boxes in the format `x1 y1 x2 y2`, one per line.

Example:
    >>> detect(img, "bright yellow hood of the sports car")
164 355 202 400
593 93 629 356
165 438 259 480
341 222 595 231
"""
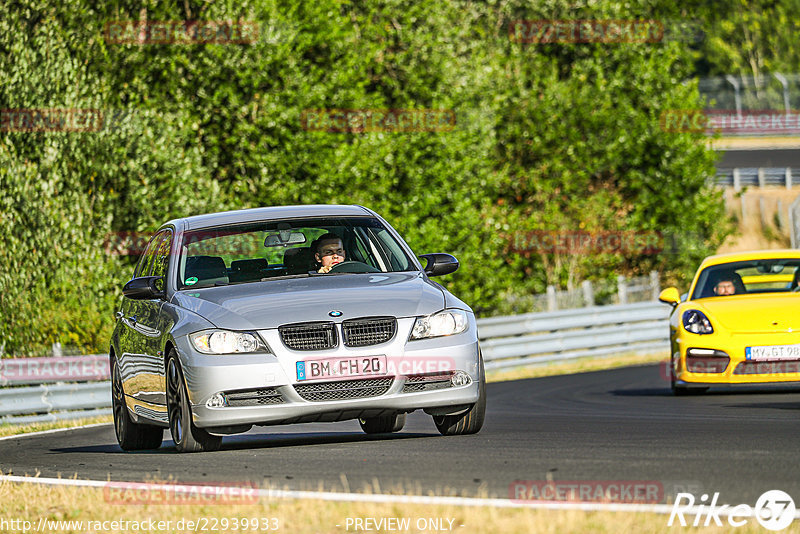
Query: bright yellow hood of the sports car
690 293 800 333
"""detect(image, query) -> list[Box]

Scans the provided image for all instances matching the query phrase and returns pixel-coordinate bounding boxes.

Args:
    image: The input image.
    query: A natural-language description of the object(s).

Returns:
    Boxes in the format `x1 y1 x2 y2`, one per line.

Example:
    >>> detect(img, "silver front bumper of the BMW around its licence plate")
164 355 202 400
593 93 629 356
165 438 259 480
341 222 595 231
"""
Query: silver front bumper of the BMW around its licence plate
175 318 483 431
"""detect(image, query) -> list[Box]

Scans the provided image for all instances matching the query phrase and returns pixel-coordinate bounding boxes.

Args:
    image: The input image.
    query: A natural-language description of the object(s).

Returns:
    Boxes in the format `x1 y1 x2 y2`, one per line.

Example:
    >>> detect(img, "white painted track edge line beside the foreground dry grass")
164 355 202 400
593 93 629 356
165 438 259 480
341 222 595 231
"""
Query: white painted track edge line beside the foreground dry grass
0 475 800 518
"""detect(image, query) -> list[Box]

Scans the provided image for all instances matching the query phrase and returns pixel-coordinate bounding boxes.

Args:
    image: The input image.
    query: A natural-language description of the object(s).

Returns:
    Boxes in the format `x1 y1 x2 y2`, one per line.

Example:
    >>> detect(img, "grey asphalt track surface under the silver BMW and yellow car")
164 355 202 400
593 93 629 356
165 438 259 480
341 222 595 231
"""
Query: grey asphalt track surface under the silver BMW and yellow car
0 365 800 505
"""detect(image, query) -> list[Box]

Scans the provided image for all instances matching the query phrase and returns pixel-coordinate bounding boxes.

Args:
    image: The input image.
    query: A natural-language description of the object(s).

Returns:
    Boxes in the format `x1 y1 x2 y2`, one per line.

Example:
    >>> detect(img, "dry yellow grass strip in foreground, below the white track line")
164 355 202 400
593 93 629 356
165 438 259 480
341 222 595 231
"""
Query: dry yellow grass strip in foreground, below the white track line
0 481 800 534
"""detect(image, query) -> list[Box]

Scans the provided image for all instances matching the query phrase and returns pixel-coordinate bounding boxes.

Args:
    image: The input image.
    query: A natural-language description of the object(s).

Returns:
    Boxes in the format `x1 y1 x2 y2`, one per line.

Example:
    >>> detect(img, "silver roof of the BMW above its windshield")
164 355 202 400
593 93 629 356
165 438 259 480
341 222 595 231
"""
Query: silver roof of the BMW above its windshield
162 204 375 231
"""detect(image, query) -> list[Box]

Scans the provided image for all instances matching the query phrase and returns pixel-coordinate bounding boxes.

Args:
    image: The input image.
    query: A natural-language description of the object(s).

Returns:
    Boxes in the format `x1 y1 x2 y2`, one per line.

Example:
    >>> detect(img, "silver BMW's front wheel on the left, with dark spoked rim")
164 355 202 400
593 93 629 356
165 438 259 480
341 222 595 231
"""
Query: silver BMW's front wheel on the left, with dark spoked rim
167 349 222 452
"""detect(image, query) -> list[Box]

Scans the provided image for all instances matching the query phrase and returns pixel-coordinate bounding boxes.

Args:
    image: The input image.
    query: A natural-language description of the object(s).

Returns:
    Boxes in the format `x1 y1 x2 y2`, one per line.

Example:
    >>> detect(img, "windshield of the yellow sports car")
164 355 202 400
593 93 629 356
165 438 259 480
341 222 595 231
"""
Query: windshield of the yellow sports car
692 258 800 299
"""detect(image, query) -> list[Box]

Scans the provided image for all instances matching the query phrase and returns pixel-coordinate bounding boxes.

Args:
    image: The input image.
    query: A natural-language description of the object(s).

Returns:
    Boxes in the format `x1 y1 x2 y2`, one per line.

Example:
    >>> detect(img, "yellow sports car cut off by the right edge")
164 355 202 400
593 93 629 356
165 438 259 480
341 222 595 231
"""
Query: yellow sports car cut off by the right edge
658 250 800 395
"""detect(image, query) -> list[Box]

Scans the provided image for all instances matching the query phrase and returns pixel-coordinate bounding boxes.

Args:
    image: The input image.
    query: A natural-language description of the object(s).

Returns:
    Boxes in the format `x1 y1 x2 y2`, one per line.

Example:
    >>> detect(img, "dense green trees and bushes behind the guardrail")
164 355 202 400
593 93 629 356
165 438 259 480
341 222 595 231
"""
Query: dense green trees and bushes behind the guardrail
0 0 752 355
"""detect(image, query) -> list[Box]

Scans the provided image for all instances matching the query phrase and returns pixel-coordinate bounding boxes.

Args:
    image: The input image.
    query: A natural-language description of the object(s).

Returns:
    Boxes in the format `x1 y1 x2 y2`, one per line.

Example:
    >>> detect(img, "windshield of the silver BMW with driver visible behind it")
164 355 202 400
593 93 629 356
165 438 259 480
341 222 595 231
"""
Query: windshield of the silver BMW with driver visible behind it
178 217 417 289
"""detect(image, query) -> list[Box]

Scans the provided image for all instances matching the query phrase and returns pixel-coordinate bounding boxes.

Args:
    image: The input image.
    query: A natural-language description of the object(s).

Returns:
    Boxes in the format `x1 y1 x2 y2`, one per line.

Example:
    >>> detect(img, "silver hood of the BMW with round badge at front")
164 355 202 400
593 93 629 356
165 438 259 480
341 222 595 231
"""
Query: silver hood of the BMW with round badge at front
172 273 445 330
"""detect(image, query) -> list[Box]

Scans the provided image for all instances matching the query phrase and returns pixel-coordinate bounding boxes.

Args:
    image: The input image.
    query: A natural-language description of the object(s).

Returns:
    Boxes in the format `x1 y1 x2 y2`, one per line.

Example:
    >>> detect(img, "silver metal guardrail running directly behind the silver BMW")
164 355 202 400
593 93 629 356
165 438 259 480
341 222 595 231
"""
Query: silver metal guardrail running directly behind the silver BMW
0 302 670 424
